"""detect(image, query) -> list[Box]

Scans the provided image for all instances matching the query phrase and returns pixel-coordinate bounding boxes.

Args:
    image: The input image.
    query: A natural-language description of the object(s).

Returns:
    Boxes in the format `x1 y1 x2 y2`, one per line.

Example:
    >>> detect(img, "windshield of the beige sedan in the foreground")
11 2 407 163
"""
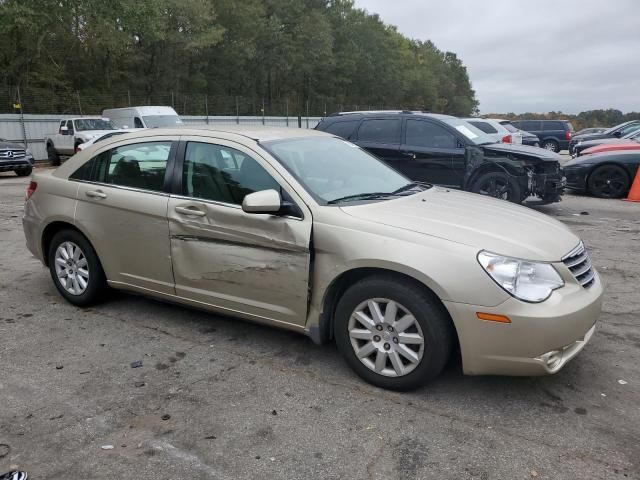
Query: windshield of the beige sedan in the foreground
262 137 427 205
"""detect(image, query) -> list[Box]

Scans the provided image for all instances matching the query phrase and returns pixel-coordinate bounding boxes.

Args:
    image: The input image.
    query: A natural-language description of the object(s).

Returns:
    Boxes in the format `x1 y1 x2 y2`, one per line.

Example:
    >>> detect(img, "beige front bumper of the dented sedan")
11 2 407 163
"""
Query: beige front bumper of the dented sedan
444 274 603 376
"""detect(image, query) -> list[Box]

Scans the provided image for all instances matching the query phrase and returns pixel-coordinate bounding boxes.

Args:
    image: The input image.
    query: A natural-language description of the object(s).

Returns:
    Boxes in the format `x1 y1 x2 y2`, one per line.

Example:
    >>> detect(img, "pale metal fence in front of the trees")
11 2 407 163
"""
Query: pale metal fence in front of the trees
0 114 321 160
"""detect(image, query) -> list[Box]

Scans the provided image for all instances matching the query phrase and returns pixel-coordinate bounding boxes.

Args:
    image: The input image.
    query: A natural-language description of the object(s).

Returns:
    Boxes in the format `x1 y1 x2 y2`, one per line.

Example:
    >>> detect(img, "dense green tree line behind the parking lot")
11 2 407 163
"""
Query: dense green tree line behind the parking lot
0 0 478 116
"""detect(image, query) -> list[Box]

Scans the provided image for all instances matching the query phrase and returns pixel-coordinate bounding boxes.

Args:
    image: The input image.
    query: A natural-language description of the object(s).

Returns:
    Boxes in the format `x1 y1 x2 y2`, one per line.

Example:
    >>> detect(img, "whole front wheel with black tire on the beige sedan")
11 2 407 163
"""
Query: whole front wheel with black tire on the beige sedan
334 276 453 390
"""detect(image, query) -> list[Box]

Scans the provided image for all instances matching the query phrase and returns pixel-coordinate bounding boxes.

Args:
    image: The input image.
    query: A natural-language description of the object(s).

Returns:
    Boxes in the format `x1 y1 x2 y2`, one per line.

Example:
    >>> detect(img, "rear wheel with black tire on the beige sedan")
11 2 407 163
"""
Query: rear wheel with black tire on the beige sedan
48 230 108 307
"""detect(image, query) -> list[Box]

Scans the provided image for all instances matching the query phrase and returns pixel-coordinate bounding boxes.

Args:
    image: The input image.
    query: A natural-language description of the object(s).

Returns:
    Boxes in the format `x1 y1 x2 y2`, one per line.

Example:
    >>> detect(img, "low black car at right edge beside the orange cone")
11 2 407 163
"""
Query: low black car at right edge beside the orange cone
564 150 640 198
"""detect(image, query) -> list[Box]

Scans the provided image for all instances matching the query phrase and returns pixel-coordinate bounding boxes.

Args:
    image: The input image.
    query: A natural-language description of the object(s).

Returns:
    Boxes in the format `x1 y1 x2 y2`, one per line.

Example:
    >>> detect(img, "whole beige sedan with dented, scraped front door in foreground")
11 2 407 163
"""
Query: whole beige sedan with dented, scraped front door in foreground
23 126 602 389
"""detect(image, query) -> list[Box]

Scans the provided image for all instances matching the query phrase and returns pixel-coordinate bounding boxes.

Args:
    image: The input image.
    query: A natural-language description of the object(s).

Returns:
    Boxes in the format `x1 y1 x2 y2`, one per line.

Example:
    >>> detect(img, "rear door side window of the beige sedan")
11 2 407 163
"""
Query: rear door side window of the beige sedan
70 142 171 192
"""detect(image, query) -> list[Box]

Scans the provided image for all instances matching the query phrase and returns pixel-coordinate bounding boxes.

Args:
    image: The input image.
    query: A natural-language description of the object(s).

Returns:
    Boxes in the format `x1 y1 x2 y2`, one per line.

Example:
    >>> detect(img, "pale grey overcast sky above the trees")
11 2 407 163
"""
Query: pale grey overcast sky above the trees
356 0 640 113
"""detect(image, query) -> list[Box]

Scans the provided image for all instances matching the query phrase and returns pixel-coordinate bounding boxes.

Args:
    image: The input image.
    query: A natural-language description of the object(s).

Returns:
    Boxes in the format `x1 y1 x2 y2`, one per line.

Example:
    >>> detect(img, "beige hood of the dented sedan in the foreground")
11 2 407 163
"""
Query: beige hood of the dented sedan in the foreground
341 187 580 262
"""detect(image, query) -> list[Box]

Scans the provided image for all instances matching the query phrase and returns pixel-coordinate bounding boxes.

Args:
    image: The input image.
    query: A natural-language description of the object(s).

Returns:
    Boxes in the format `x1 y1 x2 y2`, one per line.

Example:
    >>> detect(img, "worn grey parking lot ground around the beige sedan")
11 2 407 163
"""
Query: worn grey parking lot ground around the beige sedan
0 167 640 480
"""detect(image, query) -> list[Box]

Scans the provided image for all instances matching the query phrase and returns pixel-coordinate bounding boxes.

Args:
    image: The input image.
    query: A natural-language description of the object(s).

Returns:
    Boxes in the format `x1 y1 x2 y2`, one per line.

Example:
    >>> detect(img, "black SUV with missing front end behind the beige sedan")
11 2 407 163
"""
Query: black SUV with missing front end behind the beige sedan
316 111 564 203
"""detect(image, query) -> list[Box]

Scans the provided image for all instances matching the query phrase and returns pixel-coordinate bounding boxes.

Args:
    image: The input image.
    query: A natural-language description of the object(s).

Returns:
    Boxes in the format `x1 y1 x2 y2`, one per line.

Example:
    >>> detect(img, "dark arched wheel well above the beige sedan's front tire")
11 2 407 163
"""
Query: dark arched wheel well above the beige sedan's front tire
320 268 460 350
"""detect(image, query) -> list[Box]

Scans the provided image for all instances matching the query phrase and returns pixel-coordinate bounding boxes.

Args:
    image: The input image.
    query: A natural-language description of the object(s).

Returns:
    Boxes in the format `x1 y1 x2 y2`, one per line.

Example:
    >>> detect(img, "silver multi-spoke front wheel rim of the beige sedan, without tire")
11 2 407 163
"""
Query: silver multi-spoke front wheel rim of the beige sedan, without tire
348 298 425 377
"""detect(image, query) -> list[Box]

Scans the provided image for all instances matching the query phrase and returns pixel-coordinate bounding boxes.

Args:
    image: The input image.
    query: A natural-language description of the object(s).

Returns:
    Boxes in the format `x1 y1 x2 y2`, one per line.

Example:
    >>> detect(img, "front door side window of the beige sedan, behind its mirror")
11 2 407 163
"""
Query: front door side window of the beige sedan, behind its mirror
182 142 281 205
